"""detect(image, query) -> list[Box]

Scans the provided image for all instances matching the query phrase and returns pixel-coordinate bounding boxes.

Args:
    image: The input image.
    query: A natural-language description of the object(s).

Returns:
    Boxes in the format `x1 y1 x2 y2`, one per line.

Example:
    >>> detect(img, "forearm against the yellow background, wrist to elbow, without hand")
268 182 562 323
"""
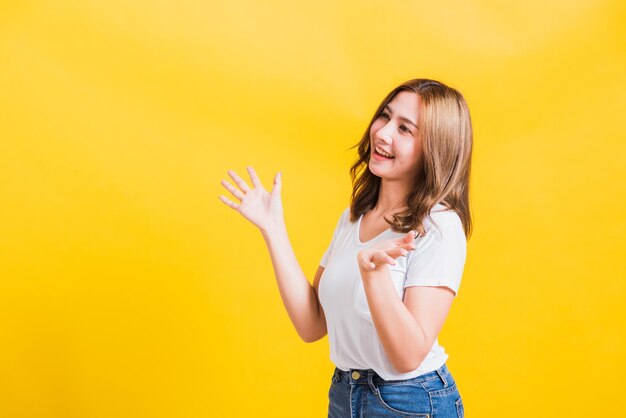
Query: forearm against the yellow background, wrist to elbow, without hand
261 224 326 342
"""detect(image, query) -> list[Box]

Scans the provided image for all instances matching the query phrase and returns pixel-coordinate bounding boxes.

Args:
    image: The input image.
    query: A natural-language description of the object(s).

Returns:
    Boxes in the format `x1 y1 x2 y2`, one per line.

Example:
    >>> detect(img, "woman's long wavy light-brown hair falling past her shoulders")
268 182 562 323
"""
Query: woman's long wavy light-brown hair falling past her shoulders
348 78 473 239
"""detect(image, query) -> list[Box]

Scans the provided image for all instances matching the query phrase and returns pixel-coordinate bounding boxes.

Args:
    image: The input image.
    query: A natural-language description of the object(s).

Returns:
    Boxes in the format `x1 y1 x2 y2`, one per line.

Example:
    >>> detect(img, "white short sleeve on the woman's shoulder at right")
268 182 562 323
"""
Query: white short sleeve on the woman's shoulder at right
404 217 467 297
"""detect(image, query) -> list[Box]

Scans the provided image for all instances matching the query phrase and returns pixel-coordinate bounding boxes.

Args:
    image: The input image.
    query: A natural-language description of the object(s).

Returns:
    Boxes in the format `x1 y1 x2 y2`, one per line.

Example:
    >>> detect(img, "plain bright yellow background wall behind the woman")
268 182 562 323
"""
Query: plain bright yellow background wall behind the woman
0 0 626 418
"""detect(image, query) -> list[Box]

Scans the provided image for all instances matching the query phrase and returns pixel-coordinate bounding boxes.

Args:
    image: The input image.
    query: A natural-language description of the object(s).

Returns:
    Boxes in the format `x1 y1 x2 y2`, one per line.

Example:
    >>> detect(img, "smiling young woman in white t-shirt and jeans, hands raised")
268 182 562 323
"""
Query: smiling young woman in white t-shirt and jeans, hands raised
220 79 473 418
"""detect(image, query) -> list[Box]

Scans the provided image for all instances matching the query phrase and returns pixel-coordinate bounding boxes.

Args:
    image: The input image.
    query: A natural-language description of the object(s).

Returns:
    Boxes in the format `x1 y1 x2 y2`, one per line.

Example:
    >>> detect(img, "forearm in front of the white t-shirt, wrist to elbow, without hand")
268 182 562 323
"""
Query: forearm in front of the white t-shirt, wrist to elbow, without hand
361 268 430 373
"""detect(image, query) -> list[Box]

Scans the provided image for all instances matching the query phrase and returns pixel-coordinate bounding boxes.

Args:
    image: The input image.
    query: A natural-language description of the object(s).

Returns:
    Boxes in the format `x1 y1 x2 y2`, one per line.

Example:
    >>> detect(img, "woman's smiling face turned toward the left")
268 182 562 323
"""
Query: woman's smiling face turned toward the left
369 91 422 180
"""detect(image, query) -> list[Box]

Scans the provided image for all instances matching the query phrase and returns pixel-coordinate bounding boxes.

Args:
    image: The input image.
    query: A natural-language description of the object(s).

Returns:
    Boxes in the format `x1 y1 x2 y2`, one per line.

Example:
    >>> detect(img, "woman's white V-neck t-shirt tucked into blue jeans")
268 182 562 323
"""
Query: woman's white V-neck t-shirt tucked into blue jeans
319 204 467 380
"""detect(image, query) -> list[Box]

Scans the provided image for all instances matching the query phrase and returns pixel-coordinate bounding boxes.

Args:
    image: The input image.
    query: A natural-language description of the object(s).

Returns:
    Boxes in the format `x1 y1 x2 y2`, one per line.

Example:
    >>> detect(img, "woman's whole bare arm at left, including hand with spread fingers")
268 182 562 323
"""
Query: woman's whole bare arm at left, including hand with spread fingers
220 166 327 342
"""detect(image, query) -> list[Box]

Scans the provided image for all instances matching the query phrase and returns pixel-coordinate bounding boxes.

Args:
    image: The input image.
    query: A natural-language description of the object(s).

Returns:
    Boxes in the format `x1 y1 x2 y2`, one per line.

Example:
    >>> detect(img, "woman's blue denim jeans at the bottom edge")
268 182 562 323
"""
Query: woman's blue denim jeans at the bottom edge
328 364 464 418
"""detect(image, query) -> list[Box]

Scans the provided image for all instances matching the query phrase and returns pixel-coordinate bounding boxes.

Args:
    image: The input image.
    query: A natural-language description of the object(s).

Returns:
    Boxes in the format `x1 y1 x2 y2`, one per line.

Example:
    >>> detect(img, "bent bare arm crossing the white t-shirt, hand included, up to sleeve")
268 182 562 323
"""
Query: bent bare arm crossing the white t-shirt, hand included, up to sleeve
357 233 454 373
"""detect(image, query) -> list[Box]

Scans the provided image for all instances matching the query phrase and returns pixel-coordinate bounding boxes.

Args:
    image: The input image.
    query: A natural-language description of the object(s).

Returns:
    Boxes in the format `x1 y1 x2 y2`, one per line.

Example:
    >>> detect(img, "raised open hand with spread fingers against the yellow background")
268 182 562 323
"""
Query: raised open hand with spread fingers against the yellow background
219 166 284 231
